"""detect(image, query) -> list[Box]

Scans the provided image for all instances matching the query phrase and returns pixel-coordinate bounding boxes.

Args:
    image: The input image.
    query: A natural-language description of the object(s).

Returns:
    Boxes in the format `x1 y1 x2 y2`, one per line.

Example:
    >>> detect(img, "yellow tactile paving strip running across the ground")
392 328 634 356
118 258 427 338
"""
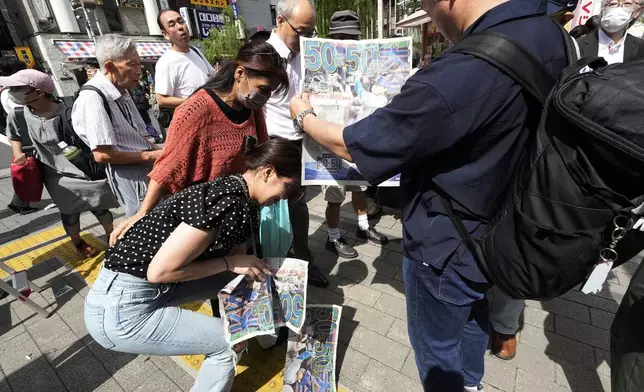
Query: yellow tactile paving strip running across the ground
0 226 347 392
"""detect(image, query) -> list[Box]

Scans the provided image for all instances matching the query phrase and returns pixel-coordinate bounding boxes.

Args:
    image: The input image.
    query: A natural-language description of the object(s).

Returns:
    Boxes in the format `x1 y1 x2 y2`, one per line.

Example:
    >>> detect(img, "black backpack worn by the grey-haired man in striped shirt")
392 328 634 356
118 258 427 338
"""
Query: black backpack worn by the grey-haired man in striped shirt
54 85 112 181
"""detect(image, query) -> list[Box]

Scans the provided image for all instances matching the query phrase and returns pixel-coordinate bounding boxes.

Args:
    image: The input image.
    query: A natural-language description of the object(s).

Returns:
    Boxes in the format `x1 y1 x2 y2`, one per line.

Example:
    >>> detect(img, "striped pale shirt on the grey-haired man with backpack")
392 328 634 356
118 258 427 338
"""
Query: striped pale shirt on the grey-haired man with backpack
72 72 151 152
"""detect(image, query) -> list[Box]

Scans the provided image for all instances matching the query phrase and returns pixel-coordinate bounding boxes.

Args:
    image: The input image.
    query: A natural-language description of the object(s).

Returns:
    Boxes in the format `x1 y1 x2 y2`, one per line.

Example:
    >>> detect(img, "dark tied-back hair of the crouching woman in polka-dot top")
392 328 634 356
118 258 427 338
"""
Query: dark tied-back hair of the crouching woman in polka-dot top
242 136 302 182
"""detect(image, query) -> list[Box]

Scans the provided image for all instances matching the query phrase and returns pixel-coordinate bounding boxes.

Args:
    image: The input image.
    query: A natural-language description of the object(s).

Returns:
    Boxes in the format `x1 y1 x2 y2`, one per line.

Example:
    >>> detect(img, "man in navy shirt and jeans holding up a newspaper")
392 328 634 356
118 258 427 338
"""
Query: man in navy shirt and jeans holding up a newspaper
291 0 566 392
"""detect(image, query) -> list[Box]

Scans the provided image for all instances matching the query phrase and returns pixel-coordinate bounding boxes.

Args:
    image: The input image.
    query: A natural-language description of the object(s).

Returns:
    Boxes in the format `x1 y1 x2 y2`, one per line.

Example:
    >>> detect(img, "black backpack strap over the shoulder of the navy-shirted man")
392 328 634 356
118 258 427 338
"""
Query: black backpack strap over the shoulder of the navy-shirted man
450 31 555 104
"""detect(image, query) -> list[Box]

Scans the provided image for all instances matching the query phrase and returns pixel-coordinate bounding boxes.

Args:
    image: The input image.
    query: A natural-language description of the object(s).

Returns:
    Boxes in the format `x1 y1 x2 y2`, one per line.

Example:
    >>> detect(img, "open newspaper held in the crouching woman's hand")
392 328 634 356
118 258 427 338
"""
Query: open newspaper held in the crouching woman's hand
218 257 308 345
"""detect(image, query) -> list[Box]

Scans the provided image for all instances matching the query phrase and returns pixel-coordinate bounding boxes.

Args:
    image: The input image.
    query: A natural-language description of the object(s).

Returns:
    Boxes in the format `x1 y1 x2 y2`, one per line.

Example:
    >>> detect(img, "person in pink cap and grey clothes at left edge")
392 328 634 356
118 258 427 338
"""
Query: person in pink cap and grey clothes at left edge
0 69 118 257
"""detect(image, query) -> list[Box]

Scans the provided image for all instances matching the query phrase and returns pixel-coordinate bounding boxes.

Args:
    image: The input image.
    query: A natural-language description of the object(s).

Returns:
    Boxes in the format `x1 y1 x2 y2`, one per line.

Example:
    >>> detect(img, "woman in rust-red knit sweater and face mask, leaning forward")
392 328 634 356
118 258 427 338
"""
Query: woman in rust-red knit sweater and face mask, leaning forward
110 42 288 245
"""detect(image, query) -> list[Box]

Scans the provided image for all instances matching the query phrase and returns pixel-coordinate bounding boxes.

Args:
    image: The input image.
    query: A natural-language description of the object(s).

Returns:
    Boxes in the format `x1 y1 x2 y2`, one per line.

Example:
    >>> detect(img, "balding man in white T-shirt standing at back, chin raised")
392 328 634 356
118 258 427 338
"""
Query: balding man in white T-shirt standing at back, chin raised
154 10 215 109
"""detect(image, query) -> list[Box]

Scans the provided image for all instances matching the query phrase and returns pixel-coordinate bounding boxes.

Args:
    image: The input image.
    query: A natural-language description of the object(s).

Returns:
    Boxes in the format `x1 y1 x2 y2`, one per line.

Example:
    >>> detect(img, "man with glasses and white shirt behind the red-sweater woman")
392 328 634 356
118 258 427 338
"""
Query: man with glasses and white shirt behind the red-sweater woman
264 0 329 287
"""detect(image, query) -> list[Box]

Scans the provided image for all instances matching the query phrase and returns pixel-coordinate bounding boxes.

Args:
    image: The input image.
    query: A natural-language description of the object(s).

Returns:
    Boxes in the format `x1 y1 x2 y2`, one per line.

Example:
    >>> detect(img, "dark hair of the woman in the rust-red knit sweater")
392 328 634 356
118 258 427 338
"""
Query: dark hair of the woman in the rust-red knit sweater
203 42 288 94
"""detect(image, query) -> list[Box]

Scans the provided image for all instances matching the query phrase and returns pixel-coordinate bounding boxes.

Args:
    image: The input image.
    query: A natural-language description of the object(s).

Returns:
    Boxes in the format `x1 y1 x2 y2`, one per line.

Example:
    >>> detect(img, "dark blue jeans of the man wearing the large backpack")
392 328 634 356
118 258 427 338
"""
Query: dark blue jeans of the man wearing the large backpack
403 257 489 392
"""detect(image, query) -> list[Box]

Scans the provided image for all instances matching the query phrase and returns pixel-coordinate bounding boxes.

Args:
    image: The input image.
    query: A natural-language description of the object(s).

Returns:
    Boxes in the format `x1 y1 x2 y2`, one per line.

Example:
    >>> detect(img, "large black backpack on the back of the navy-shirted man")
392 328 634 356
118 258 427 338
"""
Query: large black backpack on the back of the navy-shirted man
437 23 644 299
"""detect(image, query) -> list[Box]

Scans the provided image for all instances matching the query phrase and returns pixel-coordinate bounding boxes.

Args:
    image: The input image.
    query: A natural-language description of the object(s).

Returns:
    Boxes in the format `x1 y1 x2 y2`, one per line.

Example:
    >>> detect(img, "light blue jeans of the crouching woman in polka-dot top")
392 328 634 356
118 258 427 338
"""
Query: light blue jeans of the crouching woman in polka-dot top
85 268 235 392
